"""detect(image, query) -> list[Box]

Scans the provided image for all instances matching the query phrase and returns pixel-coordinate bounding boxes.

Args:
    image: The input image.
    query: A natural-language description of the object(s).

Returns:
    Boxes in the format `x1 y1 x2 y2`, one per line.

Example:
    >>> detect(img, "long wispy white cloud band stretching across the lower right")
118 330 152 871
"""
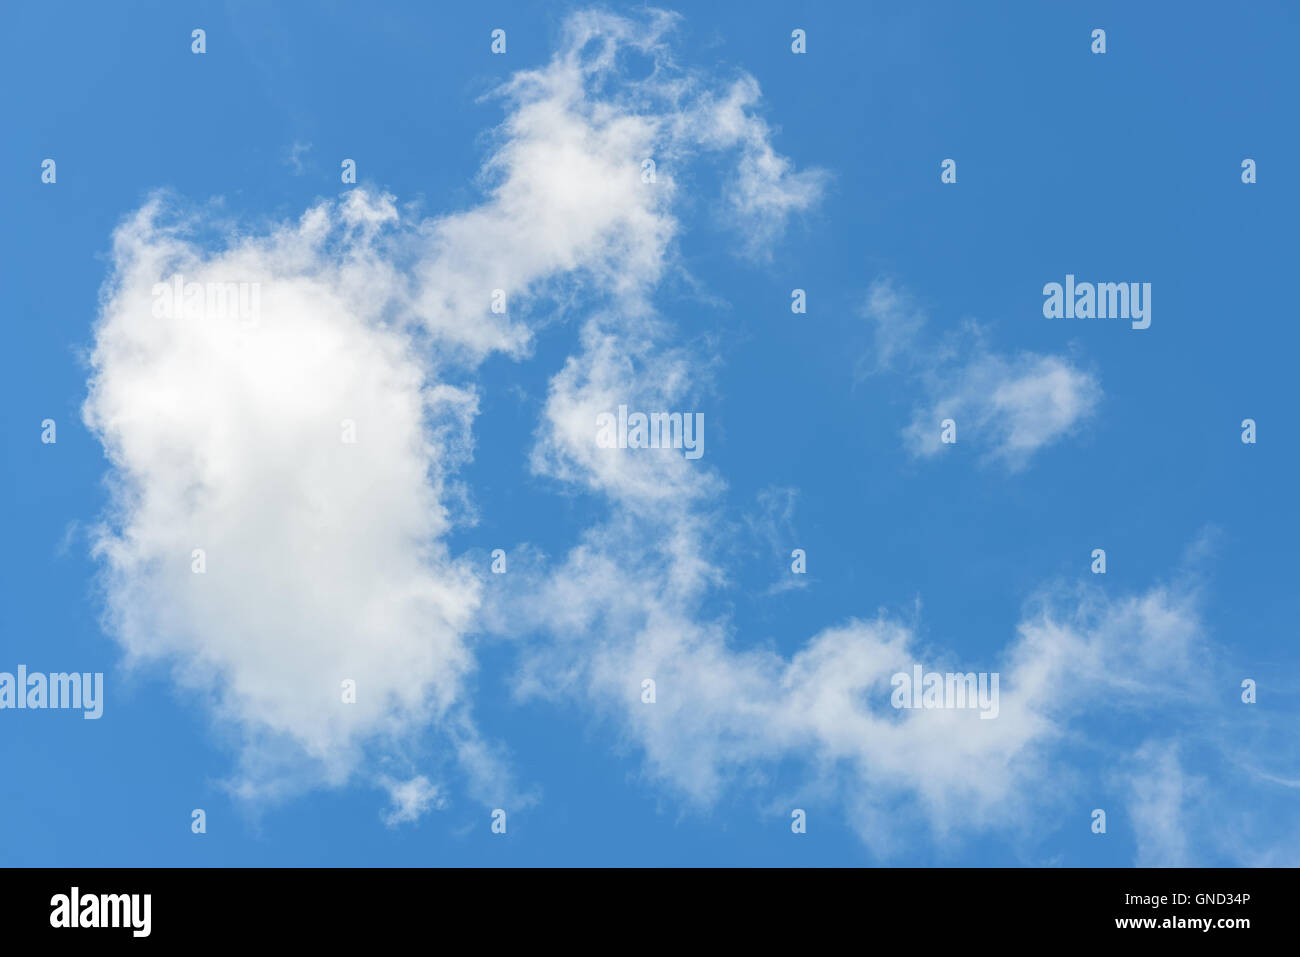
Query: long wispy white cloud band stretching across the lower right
520 512 1203 853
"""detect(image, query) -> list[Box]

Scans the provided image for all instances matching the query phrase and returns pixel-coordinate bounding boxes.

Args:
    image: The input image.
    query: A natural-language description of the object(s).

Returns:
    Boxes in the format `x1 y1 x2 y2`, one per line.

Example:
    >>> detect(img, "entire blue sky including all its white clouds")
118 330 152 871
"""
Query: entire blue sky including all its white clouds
0 3 1300 866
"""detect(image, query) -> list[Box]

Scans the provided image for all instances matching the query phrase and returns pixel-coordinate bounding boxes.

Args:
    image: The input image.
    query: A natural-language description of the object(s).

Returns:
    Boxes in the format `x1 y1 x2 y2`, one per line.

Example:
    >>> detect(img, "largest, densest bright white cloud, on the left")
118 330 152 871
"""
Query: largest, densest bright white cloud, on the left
85 194 480 791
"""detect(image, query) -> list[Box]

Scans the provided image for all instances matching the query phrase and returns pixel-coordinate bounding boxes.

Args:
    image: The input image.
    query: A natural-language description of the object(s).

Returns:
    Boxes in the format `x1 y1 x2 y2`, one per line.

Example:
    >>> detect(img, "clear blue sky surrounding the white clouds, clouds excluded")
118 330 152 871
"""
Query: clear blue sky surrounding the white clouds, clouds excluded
0 0 1300 866
